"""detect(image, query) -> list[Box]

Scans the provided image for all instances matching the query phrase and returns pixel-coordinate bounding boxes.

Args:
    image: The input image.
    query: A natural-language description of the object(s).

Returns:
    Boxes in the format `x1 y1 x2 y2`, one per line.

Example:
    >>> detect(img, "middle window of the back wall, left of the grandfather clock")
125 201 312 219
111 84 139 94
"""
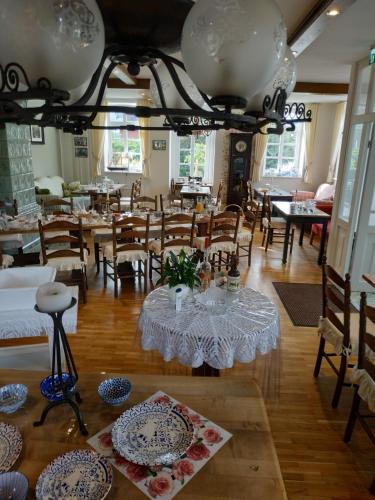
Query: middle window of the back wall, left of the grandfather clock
170 132 215 182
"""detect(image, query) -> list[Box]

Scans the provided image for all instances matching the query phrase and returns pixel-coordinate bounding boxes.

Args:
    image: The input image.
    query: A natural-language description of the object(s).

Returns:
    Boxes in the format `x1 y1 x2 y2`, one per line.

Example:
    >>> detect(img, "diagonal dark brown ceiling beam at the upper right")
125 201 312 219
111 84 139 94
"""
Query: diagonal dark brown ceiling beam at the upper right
288 0 357 57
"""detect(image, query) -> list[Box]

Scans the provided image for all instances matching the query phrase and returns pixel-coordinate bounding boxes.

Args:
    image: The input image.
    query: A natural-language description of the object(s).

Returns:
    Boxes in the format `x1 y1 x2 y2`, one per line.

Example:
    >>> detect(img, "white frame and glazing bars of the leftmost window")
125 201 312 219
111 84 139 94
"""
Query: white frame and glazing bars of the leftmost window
104 101 144 174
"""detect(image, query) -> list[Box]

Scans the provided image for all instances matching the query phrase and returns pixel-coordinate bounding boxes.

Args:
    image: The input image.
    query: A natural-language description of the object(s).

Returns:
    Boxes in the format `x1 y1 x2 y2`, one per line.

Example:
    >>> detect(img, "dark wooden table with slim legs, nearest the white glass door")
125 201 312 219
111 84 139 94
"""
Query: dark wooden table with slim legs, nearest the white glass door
272 201 331 265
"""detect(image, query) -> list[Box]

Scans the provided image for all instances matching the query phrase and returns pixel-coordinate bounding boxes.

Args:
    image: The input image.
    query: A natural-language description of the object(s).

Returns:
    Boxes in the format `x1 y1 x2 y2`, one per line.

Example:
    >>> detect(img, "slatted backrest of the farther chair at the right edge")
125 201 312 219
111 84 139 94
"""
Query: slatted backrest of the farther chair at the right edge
322 257 351 348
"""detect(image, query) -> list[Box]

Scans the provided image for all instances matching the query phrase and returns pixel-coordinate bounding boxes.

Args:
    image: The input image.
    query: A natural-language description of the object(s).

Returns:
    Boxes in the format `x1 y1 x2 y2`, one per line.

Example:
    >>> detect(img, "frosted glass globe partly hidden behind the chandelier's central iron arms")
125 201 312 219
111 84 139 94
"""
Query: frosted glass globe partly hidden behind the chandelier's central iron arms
150 62 207 109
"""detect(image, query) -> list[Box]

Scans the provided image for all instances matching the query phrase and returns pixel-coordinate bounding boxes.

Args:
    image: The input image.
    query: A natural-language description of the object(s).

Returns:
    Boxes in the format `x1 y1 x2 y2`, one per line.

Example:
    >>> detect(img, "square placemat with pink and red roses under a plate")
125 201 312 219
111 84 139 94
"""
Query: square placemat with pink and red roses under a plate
87 391 232 500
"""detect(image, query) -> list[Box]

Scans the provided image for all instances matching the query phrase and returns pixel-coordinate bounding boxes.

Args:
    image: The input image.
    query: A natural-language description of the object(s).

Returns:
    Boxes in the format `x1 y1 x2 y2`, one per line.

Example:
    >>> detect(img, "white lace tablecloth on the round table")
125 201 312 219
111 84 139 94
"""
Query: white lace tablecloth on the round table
139 287 279 369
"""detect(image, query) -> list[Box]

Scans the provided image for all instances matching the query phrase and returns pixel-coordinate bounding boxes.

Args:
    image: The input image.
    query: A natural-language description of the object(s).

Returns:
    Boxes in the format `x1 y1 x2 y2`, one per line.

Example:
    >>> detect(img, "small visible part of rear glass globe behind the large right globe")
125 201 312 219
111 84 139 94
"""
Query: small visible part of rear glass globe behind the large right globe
246 47 297 111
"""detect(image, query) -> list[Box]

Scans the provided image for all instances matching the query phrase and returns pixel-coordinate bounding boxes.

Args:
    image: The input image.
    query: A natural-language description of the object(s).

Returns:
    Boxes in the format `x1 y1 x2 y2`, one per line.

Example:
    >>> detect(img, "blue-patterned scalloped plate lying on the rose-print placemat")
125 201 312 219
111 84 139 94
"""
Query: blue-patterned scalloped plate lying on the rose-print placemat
112 403 194 466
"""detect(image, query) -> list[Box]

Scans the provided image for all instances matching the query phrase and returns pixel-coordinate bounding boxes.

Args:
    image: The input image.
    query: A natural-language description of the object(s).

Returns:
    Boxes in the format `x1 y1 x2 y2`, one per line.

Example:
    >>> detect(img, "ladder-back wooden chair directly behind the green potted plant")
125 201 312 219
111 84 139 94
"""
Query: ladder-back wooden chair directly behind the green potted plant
149 212 197 281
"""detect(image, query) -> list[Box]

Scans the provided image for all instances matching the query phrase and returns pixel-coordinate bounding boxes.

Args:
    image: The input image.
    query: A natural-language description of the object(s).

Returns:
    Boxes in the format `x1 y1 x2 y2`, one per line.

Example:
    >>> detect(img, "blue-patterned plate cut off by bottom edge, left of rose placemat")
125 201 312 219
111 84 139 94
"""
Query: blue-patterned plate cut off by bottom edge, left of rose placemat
35 450 112 500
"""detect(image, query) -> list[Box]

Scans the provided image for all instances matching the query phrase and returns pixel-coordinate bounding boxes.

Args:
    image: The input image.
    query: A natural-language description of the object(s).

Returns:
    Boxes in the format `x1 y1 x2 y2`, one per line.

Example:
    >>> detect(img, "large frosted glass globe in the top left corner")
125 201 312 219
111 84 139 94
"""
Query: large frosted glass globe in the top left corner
0 0 104 90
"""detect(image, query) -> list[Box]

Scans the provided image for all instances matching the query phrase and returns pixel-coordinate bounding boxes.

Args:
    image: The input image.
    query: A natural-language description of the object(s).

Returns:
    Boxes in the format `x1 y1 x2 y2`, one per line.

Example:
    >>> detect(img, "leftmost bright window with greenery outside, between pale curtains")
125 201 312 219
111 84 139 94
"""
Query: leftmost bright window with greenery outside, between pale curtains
104 103 143 173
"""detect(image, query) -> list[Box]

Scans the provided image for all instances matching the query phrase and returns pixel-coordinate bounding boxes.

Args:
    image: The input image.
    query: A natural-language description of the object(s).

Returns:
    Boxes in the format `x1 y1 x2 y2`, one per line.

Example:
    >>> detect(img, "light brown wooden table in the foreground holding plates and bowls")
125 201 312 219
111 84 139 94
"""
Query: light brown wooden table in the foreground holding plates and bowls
0 370 287 500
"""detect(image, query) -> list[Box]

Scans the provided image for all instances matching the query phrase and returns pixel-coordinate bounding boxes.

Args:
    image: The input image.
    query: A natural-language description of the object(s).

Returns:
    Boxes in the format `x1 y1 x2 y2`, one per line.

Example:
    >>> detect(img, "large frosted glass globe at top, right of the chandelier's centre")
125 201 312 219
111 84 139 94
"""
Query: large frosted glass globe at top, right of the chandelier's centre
181 0 286 104
